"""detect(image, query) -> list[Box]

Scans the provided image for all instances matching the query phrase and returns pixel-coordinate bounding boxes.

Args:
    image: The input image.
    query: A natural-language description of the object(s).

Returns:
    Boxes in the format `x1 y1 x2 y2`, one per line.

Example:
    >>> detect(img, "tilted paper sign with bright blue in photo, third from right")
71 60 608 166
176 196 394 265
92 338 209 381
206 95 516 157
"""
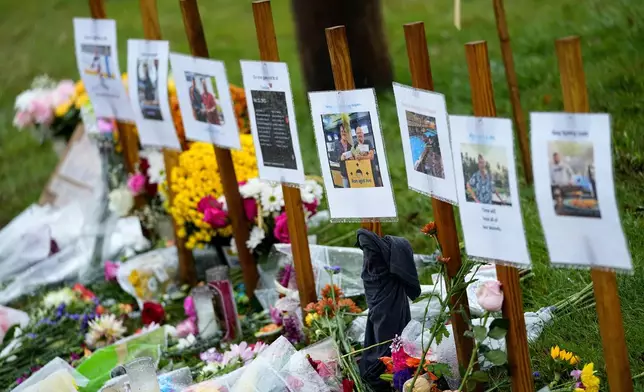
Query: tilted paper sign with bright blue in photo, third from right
394 83 457 204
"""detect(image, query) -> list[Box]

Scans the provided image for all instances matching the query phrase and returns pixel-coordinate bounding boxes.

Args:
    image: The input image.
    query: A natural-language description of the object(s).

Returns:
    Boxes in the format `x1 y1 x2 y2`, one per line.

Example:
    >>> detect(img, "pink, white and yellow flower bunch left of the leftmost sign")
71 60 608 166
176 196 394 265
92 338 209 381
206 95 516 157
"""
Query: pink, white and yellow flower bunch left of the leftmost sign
13 75 89 142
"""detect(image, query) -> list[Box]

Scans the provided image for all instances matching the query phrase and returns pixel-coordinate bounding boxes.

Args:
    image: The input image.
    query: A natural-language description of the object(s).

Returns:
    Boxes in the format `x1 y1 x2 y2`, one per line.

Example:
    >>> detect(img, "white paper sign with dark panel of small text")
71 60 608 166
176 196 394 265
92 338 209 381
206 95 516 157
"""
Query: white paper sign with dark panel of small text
241 61 304 184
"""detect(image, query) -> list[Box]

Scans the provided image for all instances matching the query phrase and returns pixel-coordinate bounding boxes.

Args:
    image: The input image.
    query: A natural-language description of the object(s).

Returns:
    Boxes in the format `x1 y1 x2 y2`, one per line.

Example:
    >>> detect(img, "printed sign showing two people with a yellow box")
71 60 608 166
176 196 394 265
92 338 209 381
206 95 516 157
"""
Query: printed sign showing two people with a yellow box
309 89 396 220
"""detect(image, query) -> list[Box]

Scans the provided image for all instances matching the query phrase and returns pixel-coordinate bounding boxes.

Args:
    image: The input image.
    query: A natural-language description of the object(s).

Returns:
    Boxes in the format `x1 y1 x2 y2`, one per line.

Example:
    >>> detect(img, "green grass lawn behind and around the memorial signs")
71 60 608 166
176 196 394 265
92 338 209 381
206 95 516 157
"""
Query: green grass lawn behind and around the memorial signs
0 0 644 391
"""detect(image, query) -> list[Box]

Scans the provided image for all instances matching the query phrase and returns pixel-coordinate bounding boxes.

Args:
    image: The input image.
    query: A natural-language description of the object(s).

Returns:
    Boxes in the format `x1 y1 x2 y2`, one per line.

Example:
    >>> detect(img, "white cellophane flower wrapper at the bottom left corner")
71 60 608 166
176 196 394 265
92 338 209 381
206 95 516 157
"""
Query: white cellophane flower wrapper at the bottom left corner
12 357 89 392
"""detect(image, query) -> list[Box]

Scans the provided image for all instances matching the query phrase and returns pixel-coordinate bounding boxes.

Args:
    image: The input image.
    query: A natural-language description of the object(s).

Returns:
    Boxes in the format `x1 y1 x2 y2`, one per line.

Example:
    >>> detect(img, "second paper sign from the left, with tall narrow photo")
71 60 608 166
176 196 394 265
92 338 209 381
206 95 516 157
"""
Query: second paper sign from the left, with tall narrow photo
127 39 181 149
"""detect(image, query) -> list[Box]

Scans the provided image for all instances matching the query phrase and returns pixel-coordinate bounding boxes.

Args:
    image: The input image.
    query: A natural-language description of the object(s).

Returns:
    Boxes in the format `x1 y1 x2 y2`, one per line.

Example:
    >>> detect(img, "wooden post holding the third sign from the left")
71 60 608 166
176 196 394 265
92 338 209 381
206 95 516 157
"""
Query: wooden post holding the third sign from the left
179 0 259 297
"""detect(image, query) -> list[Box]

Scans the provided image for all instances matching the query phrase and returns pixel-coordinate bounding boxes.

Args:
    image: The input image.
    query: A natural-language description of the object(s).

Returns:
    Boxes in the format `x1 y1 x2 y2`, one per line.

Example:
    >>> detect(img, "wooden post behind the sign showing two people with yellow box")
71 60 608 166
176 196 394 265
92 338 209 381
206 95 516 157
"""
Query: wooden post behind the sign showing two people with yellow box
325 26 382 236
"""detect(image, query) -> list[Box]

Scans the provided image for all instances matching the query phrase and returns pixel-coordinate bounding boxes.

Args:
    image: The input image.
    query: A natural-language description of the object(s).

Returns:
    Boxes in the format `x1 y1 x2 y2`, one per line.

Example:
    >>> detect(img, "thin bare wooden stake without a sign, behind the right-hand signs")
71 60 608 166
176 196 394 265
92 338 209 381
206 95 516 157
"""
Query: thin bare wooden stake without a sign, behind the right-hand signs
493 0 533 185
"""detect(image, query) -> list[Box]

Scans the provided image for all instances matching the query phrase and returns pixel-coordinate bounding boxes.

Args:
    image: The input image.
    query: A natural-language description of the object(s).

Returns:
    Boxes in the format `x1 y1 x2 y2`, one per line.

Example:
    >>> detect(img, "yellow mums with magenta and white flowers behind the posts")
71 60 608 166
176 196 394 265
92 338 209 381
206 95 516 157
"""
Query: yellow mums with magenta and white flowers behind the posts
170 141 322 252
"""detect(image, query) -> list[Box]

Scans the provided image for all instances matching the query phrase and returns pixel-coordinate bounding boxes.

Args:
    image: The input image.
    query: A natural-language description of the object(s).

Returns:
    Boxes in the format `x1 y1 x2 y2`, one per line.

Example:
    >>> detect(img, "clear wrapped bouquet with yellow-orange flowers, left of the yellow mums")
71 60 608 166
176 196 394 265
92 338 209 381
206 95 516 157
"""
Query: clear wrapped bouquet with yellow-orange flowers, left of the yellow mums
116 246 179 308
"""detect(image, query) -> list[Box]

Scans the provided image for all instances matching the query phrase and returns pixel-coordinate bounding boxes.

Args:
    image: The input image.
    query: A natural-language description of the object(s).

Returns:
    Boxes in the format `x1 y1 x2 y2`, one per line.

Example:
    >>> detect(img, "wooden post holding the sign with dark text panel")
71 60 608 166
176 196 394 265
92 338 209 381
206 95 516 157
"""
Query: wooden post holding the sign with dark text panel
253 0 317 308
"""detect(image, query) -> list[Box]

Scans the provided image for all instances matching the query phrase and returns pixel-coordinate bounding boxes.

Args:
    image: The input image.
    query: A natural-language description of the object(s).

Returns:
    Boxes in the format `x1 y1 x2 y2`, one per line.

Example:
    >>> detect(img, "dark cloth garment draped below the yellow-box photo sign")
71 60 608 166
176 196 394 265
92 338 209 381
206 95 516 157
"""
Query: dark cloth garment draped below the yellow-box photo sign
356 229 420 391
